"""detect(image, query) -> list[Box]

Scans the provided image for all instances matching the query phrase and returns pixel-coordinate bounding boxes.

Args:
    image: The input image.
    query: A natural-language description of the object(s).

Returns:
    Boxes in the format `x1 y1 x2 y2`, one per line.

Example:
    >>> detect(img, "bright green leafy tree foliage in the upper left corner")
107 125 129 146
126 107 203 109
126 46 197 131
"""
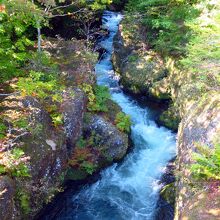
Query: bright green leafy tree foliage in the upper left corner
0 0 43 83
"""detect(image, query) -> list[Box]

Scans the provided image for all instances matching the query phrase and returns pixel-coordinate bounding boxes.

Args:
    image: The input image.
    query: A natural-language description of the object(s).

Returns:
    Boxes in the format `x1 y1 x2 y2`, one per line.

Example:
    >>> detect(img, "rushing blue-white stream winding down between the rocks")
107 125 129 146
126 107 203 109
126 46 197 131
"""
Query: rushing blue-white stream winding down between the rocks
49 11 176 220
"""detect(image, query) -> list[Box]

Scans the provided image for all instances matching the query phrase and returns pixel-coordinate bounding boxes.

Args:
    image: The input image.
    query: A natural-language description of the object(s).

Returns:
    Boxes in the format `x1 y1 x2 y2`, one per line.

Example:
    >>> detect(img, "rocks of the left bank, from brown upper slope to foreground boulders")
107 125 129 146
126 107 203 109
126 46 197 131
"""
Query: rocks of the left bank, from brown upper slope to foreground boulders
0 39 128 219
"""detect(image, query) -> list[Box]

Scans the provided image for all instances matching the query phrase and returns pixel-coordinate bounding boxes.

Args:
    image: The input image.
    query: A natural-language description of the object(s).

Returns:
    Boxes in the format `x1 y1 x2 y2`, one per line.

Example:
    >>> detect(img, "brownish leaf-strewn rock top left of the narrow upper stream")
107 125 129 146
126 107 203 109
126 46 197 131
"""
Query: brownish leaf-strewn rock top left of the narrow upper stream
43 38 98 87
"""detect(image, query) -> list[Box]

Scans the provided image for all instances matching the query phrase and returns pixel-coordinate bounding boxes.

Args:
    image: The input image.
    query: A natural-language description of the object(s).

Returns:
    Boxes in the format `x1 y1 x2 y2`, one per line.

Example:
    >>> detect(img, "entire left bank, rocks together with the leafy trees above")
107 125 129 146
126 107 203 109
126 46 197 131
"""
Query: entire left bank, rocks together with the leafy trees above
0 0 131 219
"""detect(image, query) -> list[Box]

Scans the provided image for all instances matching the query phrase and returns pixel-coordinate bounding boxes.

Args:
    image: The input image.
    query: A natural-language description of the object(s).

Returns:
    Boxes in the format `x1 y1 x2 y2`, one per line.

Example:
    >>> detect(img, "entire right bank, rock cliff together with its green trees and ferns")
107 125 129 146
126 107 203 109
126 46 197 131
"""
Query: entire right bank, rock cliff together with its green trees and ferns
113 0 220 219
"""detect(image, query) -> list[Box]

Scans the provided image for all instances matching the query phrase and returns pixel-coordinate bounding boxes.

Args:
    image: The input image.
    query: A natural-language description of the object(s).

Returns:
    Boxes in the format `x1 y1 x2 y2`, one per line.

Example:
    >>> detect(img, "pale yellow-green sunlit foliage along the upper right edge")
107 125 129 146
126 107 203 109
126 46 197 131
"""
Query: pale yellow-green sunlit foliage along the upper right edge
181 2 220 91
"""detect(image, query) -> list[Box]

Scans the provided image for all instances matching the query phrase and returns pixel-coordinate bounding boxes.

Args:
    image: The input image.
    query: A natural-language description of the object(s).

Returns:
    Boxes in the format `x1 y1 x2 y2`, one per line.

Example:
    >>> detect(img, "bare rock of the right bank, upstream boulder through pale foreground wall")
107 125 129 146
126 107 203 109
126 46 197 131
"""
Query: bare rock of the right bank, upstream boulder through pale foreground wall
113 21 220 219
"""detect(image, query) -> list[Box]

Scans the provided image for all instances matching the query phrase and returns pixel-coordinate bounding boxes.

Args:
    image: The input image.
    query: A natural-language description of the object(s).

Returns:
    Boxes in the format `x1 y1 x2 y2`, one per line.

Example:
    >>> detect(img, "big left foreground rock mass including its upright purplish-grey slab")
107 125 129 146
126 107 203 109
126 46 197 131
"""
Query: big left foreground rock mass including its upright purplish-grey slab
0 89 86 218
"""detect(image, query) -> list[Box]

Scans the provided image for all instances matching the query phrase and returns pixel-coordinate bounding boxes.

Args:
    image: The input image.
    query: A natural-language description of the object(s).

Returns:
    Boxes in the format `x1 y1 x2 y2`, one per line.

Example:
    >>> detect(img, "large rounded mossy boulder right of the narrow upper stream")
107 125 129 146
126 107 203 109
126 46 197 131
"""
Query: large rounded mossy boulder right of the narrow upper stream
113 24 170 99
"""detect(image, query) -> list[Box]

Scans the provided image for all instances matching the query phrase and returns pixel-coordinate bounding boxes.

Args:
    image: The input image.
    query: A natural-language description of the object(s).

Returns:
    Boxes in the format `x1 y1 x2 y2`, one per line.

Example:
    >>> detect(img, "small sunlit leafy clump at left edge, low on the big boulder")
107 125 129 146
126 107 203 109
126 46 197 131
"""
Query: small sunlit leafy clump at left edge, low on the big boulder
0 148 30 177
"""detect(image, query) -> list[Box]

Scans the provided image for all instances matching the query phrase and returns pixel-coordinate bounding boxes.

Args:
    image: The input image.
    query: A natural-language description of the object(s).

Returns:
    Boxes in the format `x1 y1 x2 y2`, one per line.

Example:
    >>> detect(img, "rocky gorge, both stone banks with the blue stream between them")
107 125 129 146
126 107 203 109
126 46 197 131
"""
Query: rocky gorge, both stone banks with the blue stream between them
0 1 220 220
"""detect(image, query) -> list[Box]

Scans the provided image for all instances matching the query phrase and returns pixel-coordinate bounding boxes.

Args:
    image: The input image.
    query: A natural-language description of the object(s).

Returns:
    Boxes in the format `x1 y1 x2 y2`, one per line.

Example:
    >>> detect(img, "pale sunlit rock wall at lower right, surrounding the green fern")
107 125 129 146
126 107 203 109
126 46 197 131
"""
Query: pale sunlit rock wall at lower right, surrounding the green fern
176 93 220 220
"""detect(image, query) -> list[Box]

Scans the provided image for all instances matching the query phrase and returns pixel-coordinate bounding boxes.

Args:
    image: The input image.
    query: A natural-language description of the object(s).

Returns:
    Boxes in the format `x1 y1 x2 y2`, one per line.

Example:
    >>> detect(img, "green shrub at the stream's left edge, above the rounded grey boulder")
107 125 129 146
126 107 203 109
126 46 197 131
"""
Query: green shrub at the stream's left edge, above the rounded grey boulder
81 84 110 112
